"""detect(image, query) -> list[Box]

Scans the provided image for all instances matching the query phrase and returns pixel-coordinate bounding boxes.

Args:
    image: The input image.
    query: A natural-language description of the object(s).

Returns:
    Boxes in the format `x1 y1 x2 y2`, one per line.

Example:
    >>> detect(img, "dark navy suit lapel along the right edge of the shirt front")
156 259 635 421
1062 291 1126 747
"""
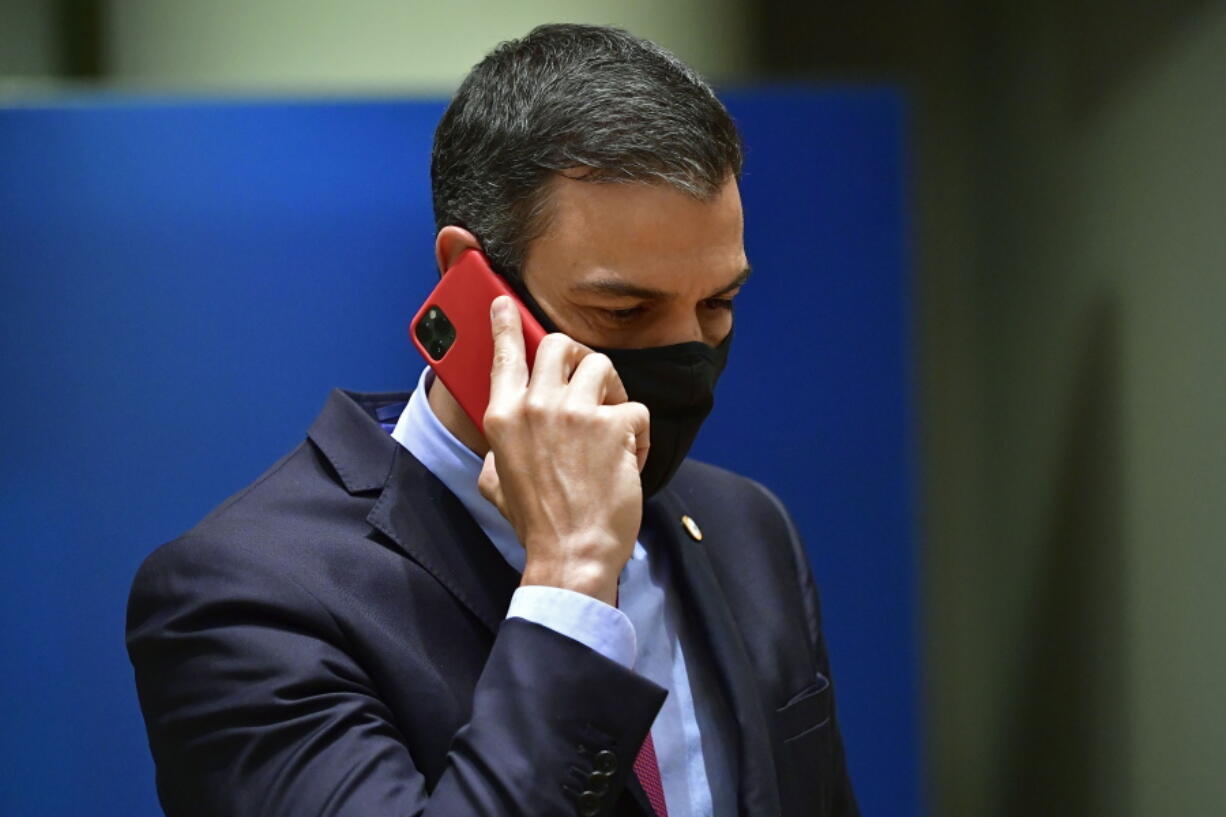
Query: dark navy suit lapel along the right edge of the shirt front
642 488 780 816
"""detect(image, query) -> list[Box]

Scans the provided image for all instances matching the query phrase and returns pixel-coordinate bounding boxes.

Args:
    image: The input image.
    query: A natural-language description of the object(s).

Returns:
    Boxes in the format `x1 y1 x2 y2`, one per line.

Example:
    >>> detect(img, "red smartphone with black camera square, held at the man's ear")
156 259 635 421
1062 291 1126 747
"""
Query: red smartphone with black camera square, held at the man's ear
408 249 547 433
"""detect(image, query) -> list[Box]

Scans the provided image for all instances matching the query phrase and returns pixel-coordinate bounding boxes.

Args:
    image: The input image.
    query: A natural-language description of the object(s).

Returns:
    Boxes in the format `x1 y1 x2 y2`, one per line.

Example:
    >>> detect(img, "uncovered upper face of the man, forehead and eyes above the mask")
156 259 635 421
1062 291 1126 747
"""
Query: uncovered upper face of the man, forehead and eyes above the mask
522 175 749 348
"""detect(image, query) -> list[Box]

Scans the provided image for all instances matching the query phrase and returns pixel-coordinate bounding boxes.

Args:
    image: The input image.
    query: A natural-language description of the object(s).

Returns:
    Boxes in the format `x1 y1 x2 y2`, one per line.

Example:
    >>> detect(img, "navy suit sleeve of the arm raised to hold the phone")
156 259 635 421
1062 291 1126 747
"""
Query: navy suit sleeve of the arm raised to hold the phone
128 539 664 817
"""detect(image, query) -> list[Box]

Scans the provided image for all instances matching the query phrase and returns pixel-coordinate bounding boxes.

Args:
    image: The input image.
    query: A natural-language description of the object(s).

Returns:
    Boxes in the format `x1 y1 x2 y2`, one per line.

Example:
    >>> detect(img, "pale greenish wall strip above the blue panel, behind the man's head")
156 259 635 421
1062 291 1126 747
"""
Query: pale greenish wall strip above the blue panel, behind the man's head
107 0 749 93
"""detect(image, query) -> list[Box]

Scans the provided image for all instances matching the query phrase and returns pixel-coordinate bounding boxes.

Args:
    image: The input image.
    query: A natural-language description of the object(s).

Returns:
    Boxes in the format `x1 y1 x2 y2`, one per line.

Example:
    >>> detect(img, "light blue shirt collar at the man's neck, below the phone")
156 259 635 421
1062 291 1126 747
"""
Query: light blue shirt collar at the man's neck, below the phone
391 367 525 573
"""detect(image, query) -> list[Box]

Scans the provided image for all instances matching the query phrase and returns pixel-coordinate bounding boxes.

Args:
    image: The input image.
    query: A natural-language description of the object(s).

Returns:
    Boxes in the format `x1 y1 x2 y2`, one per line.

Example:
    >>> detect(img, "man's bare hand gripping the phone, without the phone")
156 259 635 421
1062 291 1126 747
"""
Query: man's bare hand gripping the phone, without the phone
478 298 650 605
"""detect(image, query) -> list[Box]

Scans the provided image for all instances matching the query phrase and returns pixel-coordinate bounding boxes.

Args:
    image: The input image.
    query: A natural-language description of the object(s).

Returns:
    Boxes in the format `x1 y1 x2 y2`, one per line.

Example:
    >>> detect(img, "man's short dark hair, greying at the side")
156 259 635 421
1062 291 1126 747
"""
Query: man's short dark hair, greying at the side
430 25 742 276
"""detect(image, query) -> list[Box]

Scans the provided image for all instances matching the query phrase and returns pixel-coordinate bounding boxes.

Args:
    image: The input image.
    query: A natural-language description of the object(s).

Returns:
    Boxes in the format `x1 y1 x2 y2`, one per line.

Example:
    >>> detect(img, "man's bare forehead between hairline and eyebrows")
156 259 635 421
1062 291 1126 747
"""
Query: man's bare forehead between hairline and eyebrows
525 175 745 290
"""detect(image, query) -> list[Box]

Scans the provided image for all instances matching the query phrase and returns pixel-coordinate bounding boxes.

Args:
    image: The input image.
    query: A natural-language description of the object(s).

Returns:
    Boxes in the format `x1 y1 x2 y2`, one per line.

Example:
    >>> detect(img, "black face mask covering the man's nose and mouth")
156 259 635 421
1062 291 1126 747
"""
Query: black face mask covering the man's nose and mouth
508 272 732 499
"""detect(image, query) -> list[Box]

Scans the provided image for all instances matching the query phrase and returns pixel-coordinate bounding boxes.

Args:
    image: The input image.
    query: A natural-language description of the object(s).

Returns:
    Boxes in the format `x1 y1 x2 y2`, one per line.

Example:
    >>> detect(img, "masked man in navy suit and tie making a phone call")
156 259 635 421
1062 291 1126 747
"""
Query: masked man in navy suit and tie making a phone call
128 26 856 817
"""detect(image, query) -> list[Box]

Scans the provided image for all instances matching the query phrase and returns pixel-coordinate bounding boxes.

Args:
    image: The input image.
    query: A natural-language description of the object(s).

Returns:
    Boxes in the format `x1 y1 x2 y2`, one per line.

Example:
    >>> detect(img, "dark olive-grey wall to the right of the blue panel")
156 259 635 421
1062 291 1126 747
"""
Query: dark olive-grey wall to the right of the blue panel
759 0 1226 817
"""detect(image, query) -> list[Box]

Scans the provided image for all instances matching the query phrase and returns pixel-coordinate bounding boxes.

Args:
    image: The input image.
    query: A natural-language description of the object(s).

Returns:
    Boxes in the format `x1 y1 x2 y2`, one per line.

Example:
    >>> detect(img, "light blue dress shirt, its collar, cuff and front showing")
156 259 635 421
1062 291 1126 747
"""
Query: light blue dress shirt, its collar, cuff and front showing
391 368 737 817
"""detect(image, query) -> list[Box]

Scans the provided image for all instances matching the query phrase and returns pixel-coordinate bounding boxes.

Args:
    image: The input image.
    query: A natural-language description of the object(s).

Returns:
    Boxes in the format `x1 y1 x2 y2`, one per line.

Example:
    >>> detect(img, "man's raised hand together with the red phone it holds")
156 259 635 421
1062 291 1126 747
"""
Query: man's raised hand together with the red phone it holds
411 250 650 604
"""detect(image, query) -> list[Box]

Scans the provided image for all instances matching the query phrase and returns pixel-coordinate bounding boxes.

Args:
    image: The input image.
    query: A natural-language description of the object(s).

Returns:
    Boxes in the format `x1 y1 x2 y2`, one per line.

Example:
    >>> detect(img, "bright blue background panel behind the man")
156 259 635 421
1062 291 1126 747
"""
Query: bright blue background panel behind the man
0 95 920 817
